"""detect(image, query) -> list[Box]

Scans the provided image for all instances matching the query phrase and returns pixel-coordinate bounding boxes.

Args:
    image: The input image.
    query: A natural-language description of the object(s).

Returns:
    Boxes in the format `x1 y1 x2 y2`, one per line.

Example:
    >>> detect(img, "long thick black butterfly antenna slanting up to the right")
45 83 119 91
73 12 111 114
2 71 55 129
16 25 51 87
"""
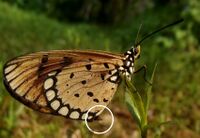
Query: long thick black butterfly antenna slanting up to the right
136 19 184 46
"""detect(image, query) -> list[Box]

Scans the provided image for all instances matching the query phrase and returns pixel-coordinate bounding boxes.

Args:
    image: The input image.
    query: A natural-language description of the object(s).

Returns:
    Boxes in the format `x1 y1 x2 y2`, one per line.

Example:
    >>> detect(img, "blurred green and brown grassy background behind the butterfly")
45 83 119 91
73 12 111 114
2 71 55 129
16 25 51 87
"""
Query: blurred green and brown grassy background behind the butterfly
0 0 200 138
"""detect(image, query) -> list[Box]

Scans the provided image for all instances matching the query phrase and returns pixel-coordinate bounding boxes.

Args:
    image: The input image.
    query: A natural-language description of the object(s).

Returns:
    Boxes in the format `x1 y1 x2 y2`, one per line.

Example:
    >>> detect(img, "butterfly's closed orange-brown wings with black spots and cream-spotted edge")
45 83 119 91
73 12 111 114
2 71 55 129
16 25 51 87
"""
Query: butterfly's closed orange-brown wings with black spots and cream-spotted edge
4 50 123 120
